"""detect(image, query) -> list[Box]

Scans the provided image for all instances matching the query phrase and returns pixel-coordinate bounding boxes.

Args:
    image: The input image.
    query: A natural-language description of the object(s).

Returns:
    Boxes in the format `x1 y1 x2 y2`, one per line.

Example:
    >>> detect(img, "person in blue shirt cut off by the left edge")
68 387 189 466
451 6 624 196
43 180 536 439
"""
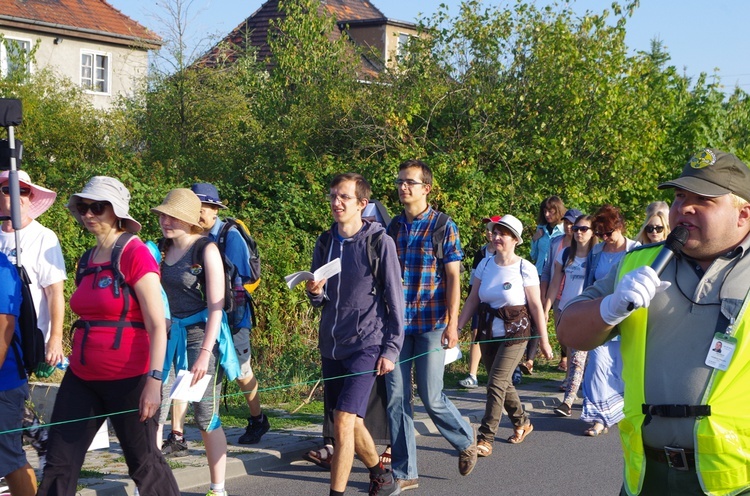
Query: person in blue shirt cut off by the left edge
0 253 36 496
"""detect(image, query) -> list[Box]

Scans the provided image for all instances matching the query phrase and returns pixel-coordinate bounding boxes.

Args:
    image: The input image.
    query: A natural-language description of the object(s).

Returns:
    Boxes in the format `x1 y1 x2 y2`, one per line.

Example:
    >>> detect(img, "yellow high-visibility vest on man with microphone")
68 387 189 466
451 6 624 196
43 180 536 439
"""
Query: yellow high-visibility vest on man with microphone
618 246 750 496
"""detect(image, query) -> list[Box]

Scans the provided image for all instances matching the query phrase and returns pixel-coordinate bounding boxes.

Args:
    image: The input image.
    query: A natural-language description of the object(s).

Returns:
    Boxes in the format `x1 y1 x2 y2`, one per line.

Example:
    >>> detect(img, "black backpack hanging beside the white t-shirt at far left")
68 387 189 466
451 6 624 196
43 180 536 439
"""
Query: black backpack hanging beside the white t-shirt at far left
11 266 45 379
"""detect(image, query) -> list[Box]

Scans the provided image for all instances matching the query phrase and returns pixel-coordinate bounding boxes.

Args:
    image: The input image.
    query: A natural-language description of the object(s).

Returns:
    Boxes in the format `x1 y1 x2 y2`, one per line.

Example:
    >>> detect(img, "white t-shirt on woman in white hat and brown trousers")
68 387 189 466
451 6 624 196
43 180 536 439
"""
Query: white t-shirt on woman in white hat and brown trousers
474 257 539 338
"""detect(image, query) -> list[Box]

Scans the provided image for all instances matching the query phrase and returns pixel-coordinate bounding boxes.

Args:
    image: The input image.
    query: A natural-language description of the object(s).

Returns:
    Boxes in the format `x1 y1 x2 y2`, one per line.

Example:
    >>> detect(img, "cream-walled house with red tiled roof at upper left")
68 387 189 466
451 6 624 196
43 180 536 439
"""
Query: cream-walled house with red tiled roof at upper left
0 0 162 108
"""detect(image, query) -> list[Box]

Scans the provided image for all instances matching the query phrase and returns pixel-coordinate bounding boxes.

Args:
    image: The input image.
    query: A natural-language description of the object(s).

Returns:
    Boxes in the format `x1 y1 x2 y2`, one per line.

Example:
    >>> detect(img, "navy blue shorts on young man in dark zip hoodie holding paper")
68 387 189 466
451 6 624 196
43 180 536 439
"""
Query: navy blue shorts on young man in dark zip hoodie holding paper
322 345 380 418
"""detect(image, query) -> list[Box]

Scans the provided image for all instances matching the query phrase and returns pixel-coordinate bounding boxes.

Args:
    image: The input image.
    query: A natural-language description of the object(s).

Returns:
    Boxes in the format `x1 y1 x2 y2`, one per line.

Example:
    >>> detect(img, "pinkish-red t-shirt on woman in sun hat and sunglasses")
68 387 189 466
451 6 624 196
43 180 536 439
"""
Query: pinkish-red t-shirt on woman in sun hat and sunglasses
70 239 159 381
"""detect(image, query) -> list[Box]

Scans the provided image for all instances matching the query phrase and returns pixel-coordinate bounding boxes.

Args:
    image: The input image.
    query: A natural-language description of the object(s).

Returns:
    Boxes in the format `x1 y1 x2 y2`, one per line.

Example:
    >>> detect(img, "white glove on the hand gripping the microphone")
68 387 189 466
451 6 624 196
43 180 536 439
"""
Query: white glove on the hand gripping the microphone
599 266 672 326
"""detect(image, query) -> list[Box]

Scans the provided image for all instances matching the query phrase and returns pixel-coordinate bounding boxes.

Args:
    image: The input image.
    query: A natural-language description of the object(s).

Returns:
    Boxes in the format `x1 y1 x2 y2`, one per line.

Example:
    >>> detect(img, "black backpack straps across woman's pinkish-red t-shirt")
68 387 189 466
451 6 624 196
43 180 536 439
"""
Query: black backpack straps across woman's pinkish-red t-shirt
72 232 146 364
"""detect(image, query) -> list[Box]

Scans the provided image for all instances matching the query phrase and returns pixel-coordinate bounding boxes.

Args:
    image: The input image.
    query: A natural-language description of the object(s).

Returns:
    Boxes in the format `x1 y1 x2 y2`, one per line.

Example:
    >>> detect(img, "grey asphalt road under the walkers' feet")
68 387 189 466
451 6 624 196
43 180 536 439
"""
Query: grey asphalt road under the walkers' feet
183 408 622 496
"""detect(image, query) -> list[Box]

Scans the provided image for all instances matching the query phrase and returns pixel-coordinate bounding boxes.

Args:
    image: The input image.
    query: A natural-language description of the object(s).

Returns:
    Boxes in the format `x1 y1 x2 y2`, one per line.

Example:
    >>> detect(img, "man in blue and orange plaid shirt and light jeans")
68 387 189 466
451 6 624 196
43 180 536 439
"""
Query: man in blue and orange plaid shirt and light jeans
386 160 477 489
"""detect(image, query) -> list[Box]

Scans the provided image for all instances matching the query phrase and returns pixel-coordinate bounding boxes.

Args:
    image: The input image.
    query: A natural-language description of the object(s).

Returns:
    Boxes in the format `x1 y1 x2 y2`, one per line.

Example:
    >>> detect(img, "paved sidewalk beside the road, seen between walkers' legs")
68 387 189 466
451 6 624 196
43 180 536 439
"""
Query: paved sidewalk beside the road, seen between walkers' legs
26 378 563 496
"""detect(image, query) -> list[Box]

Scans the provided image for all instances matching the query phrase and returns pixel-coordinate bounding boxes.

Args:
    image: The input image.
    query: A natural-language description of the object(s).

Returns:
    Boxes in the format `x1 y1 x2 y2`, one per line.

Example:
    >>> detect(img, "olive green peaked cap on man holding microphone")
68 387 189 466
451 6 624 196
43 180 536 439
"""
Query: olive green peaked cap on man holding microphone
659 148 750 200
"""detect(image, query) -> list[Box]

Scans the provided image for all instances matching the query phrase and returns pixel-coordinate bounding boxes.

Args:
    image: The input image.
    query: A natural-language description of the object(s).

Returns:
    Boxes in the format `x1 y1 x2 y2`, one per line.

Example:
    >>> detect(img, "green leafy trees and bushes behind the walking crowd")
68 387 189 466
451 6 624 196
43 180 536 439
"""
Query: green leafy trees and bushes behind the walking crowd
0 0 750 396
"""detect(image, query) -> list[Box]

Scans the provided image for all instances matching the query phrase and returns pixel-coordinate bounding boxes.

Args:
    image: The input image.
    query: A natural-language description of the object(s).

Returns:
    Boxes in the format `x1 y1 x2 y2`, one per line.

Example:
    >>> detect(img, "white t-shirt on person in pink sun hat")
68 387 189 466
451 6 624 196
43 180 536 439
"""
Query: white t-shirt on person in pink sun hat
0 220 67 342
